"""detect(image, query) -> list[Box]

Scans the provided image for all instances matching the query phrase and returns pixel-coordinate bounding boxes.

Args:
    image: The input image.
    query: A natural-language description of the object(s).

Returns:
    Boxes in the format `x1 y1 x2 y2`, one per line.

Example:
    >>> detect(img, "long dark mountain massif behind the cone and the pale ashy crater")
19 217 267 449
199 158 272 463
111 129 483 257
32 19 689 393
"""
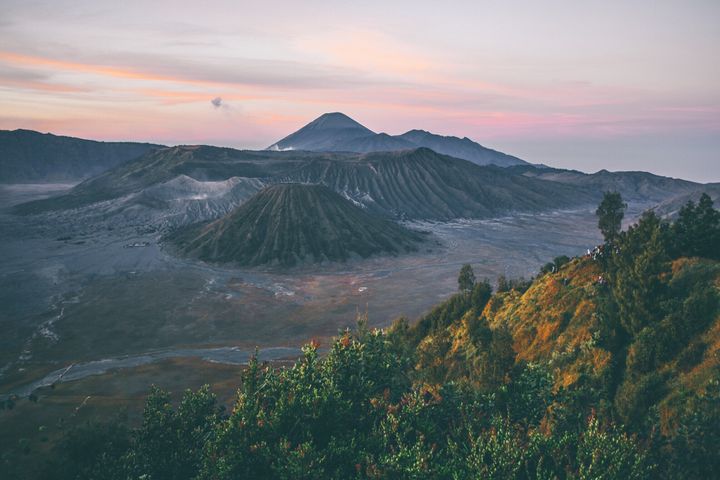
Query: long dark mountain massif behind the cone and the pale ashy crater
16 146 599 220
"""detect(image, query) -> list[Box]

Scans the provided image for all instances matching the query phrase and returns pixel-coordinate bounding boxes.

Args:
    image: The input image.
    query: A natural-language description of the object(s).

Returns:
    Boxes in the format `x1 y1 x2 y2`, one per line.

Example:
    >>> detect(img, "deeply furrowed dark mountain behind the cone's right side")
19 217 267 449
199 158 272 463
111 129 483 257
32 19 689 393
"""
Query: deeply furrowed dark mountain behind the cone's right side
272 148 597 220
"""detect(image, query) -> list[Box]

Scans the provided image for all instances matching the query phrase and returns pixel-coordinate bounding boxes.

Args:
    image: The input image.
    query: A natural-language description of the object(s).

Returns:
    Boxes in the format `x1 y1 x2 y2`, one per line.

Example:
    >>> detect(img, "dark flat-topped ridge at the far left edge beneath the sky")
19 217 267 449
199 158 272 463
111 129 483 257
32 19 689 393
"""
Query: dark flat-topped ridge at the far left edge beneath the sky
0 130 161 183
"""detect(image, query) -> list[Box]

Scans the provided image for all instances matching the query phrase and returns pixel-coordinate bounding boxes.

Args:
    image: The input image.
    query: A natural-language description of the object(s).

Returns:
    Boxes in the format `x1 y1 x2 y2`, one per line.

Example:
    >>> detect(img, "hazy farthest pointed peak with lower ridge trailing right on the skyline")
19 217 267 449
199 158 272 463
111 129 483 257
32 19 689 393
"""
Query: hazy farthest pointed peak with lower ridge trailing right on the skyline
268 112 527 167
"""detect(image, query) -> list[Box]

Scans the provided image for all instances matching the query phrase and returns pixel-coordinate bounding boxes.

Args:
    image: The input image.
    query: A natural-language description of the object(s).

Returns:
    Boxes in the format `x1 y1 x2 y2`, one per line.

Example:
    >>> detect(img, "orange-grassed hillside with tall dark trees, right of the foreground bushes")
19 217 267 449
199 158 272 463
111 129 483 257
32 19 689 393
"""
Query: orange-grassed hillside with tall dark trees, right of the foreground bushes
396 196 720 442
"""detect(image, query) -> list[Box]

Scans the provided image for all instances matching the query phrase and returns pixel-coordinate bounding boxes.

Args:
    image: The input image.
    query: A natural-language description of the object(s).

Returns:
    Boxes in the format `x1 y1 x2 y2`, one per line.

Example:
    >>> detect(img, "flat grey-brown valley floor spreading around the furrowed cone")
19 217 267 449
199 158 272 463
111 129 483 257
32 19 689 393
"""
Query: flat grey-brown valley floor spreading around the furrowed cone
0 185 612 394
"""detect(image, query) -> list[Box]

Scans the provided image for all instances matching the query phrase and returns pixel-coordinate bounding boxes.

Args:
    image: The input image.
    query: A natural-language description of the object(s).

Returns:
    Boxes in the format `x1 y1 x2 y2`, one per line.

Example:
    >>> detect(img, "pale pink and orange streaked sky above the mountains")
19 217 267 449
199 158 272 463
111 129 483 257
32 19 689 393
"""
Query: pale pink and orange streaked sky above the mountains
0 0 720 182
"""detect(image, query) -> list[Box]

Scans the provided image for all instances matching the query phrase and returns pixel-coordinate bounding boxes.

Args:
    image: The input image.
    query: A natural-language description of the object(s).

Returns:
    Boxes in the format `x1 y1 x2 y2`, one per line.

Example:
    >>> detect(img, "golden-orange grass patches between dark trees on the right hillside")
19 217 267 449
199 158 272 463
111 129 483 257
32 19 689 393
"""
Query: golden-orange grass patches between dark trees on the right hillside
422 258 720 418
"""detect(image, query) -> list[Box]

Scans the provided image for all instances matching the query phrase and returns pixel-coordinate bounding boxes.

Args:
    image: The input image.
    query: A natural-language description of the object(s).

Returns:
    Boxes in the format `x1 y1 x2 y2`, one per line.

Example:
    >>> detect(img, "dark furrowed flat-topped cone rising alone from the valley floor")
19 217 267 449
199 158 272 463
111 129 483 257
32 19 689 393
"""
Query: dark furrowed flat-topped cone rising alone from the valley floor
168 184 422 266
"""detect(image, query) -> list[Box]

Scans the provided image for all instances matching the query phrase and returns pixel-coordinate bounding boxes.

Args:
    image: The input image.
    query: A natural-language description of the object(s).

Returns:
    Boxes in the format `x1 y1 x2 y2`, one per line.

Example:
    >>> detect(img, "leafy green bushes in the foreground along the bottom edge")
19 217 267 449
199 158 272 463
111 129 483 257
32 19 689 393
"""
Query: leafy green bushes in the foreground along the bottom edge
32 326 653 479
